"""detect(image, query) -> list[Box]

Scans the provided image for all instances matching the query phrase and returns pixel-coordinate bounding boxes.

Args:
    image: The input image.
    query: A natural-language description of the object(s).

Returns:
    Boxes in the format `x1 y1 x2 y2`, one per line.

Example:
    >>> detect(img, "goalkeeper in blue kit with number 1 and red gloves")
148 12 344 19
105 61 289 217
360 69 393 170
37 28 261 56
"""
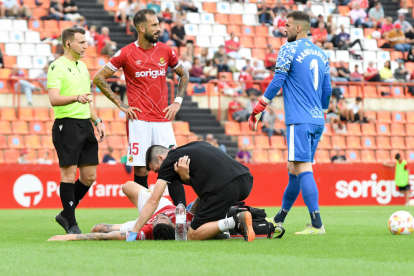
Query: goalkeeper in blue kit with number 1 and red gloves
249 11 332 235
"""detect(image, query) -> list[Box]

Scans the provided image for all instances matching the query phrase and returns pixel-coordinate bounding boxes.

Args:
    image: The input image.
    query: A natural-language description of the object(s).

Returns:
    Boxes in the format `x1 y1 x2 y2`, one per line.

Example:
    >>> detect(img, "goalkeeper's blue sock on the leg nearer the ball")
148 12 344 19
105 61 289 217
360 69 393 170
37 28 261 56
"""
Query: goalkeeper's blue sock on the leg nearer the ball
298 172 322 228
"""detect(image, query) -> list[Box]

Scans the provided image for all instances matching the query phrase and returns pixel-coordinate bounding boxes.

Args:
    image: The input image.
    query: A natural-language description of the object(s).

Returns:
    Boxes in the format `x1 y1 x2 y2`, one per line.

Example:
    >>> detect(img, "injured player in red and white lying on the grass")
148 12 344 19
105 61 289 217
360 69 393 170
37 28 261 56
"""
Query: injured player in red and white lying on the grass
48 181 229 241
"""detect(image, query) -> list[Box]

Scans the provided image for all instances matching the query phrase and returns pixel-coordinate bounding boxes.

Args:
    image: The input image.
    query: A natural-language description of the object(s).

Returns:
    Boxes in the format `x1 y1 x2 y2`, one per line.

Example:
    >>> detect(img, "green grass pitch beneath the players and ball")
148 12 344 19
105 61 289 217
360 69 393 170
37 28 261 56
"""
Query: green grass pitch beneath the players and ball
0 206 414 276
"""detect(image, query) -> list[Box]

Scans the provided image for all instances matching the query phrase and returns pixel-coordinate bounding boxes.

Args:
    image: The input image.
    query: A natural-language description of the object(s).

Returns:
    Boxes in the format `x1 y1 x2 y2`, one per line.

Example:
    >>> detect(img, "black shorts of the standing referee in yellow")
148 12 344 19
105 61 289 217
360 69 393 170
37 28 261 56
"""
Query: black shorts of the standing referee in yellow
52 118 99 167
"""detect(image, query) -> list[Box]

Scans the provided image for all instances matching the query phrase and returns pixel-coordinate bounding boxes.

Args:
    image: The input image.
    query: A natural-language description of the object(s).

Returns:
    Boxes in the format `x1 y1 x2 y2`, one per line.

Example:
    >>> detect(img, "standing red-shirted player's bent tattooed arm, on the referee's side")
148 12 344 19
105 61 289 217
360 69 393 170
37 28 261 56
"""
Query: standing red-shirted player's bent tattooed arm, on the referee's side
93 65 141 120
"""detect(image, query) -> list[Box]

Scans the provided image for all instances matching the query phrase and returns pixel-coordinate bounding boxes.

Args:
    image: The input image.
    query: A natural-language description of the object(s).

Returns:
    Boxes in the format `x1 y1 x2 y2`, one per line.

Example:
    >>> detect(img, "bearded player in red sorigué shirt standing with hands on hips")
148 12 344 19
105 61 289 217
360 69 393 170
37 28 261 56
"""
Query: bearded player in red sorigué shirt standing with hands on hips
93 9 189 205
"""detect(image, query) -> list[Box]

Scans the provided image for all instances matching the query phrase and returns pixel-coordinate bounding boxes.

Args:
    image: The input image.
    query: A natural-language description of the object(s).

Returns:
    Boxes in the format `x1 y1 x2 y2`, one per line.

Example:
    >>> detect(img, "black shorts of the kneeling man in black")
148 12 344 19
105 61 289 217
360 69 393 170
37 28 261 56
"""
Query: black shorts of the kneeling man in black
191 173 253 230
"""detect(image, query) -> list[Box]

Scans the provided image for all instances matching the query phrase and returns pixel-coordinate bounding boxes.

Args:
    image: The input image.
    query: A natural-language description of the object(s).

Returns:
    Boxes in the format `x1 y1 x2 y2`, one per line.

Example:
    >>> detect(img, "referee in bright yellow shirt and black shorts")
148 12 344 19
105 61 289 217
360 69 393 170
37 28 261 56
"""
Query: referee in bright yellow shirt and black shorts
47 27 105 234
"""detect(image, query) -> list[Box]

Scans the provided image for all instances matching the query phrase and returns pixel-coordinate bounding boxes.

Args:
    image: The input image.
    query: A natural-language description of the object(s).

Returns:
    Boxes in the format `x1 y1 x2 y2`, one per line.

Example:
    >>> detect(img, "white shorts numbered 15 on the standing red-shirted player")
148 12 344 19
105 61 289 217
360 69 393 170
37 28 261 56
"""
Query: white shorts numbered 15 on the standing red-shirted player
127 120 177 167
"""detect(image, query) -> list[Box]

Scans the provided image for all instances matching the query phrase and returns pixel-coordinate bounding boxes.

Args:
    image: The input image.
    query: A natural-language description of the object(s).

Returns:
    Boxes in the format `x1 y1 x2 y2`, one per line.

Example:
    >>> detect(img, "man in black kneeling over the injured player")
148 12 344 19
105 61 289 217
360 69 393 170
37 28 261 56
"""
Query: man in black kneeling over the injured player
127 142 255 241
